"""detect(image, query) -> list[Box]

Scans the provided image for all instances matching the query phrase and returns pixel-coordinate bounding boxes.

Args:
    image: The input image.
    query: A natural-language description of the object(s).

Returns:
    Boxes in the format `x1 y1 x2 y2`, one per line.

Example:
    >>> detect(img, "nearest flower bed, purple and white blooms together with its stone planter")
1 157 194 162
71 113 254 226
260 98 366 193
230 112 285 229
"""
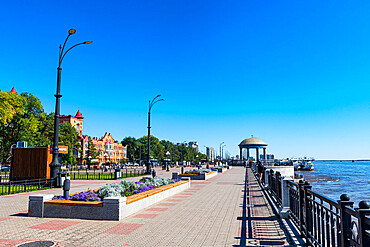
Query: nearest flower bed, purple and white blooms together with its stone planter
28 178 190 220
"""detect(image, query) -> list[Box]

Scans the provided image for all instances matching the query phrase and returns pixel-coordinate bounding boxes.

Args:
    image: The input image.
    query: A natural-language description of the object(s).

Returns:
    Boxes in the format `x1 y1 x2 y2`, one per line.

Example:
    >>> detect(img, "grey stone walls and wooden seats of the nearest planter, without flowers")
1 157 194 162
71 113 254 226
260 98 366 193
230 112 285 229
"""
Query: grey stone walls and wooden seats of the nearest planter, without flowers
28 178 190 220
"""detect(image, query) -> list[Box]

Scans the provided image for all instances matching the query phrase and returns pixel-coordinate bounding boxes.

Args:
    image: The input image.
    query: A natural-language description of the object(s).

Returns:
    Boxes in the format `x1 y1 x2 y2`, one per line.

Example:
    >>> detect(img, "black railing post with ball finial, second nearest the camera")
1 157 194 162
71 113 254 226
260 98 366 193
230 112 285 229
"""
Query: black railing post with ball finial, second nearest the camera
338 194 353 247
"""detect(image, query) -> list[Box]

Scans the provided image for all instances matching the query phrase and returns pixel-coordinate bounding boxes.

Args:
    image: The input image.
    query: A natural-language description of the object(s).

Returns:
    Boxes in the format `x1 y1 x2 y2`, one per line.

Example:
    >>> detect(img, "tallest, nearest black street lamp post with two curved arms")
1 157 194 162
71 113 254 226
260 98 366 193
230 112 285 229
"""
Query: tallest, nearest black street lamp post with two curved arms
49 29 92 183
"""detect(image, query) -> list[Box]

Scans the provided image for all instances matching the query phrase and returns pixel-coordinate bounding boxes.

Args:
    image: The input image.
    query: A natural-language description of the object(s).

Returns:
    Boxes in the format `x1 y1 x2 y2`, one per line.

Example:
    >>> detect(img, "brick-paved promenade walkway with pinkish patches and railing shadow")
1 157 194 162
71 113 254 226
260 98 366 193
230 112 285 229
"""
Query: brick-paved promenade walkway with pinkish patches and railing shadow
0 167 289 246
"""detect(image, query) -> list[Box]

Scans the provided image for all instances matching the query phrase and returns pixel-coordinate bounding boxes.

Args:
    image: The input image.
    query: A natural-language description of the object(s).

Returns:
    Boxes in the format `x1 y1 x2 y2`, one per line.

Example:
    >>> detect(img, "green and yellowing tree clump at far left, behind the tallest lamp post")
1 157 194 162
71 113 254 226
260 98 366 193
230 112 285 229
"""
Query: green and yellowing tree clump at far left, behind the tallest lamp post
0 89 80 164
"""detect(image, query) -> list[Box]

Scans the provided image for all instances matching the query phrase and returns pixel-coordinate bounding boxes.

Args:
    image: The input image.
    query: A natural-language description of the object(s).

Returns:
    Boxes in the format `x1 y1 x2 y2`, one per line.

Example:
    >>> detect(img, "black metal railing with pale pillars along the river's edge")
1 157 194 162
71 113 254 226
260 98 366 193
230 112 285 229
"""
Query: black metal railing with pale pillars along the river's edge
252 164 370 247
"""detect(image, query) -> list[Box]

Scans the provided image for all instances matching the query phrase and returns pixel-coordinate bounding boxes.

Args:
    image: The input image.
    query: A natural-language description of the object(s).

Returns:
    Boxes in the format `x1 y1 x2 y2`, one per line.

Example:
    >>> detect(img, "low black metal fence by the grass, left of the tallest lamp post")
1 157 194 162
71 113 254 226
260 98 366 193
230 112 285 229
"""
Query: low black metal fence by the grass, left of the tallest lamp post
0 178 55 195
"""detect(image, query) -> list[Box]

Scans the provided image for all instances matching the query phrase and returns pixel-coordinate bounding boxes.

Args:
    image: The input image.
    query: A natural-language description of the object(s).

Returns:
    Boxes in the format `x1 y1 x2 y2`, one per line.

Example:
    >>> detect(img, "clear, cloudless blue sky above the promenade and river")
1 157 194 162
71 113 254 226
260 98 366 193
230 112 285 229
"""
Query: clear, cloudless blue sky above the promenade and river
0 0 370 159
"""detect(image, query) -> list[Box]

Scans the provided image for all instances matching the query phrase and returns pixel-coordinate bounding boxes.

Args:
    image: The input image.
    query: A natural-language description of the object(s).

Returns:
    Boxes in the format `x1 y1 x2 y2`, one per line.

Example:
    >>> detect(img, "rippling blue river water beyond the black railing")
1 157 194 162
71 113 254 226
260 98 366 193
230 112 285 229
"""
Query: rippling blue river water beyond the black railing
296 161 370 207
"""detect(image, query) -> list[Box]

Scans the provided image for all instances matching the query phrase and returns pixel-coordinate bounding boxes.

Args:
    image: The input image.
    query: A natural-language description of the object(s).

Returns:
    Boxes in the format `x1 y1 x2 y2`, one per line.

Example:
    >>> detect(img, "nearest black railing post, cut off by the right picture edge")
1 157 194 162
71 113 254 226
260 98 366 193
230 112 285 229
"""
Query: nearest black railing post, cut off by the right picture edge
357 201 370 247
